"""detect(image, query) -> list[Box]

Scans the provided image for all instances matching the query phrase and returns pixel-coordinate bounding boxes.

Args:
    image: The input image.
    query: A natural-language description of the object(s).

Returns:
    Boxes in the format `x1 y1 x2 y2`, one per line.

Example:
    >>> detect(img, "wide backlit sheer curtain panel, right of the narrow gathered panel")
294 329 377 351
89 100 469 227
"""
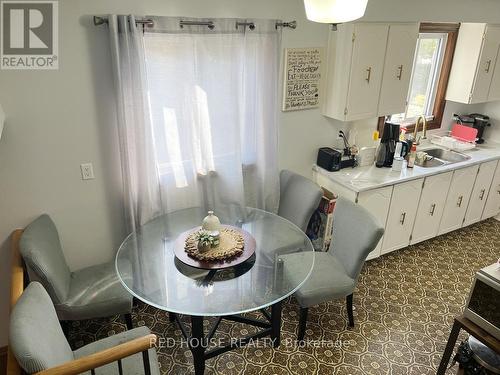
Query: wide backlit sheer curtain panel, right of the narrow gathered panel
144 21 280 210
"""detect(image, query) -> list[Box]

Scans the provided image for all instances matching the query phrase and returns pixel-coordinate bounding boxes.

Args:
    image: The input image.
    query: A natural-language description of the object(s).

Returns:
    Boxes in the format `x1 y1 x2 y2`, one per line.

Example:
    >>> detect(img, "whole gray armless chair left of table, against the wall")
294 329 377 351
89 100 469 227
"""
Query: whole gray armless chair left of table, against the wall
19 215 132 329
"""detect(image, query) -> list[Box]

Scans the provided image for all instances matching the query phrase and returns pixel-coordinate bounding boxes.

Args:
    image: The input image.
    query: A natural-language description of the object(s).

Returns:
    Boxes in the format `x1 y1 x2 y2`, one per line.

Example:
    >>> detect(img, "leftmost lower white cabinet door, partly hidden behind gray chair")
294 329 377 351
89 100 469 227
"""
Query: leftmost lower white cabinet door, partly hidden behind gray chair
358 186 392 259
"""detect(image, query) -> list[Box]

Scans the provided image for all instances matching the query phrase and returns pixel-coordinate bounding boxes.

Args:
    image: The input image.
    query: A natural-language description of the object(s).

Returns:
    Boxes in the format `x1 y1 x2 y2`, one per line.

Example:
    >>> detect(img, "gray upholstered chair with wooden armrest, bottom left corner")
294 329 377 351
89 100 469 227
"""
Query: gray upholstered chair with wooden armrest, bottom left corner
9 282 160 375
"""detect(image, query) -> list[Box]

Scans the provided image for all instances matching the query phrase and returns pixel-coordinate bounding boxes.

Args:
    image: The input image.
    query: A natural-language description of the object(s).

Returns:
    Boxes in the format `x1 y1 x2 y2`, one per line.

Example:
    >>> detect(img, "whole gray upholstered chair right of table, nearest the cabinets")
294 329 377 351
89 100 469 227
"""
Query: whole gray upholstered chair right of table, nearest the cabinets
284 198 384 341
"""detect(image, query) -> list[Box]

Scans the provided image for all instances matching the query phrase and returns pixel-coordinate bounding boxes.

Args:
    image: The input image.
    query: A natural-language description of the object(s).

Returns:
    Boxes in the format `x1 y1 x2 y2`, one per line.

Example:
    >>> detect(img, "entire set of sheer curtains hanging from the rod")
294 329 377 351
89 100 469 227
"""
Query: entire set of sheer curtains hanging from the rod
110 17 281 229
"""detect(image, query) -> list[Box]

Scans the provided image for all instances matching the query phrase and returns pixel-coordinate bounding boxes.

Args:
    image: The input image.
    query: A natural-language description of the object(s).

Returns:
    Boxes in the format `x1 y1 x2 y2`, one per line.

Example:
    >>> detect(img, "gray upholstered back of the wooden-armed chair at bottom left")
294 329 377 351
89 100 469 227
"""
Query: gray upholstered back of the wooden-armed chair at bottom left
9 281 74 374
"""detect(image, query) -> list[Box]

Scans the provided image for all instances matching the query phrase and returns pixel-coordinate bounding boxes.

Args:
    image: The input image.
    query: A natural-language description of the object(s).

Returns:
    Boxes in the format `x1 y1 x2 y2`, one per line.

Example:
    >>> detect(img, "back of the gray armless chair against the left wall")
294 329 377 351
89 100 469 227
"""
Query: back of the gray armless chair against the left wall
20 214 71 304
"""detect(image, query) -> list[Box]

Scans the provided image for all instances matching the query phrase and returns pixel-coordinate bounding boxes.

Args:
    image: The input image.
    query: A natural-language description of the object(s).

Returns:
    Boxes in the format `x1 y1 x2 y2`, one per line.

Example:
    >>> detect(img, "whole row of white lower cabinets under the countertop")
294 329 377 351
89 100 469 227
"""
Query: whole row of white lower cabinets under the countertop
314 160 500 259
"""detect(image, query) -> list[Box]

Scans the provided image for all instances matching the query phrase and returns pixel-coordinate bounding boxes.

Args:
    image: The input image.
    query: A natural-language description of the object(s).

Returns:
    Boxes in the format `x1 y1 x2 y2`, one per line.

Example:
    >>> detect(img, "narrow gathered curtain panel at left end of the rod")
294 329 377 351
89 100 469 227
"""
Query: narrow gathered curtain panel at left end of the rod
108 15 163 231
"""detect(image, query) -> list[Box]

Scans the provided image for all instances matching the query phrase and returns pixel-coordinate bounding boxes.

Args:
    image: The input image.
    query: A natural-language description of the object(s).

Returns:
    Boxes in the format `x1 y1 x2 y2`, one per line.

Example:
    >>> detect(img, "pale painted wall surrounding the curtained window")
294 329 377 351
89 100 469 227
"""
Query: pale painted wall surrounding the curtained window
0 0 500 346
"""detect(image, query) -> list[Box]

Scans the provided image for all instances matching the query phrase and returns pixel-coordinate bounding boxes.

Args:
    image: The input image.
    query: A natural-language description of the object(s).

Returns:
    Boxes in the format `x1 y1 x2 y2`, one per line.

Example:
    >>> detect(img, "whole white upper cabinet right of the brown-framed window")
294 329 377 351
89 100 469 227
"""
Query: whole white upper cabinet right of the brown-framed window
446 23 500 104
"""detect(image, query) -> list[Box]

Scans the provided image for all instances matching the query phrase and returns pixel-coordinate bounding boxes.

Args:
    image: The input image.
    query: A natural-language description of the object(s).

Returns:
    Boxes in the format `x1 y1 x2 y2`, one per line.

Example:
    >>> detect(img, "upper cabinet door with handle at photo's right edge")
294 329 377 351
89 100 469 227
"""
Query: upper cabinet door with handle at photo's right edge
471 25 500 103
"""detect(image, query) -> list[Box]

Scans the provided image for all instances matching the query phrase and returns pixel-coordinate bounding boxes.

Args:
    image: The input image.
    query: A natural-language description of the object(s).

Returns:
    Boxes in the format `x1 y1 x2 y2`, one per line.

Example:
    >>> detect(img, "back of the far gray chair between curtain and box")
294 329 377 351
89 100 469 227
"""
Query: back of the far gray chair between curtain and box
278 170 323 232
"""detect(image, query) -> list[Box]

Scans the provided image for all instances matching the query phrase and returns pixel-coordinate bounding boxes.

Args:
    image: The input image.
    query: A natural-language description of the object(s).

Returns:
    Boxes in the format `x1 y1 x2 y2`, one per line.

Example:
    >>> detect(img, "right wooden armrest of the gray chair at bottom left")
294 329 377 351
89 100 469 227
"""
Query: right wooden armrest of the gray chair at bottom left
36 334 156 375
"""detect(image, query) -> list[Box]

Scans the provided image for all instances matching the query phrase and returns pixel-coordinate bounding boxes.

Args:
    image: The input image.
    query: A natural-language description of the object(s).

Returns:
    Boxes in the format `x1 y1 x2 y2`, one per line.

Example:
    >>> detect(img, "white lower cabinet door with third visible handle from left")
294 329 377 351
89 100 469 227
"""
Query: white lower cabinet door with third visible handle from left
438 165 479 234
